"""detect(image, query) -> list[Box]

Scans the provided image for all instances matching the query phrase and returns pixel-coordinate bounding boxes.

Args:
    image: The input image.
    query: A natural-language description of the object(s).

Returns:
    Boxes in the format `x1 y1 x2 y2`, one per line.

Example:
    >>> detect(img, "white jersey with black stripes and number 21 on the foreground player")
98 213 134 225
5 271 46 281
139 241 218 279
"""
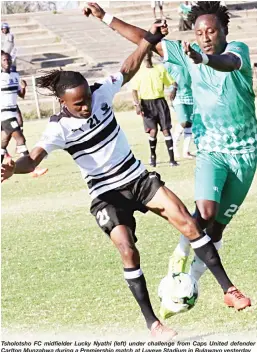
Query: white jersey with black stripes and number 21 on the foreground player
36 72 145 199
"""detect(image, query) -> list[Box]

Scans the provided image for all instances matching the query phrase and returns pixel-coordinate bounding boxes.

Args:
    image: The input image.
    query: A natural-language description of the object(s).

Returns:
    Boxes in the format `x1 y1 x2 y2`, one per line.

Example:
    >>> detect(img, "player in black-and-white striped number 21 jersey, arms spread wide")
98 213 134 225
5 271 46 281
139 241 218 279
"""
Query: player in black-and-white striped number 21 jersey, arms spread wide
1 24 246 340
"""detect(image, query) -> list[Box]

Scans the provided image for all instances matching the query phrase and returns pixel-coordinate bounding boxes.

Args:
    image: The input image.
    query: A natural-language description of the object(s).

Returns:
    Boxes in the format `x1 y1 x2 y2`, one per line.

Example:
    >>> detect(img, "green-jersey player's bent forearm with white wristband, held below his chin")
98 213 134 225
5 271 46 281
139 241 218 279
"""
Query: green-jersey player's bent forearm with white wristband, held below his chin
183 42 241 72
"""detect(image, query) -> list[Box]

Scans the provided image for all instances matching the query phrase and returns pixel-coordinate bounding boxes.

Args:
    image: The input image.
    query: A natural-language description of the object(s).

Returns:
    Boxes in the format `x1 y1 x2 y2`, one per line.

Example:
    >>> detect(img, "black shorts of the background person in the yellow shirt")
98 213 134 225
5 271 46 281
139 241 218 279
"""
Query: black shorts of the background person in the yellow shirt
141 98 172 133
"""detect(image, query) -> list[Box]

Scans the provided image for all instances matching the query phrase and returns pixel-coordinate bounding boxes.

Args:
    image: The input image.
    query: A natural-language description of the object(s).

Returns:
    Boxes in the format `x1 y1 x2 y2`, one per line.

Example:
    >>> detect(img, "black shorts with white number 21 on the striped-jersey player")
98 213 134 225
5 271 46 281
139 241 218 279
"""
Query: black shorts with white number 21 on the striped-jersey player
90 171 164 242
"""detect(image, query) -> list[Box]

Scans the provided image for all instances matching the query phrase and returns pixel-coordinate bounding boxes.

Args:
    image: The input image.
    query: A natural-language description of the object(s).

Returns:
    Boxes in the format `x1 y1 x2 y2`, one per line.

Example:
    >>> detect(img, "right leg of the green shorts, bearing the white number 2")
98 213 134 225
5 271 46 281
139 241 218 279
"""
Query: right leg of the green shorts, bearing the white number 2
216 153 257 225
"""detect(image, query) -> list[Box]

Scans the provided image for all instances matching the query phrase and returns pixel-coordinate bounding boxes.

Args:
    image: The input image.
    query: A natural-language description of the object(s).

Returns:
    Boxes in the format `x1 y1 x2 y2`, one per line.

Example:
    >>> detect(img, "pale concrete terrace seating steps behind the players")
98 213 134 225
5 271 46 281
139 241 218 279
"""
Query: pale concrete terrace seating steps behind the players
2 1 257 108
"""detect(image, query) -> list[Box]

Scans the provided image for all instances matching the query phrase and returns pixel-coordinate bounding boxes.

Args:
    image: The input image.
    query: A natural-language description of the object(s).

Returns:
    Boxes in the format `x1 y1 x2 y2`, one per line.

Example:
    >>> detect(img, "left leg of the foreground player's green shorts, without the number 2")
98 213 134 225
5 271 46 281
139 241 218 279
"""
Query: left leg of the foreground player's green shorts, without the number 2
195 151 228 203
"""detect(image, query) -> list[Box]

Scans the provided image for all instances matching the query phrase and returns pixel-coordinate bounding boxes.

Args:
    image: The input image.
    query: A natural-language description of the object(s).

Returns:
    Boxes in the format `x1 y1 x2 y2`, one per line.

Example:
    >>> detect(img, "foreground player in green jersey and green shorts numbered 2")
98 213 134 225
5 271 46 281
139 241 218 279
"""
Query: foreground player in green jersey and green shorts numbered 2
86 1 257 310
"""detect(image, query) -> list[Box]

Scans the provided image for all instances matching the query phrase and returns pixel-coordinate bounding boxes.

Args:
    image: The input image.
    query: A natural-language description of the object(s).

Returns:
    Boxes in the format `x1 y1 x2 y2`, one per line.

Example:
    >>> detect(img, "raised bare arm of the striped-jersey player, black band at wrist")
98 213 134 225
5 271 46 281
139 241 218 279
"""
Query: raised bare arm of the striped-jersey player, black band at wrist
120 22 164 85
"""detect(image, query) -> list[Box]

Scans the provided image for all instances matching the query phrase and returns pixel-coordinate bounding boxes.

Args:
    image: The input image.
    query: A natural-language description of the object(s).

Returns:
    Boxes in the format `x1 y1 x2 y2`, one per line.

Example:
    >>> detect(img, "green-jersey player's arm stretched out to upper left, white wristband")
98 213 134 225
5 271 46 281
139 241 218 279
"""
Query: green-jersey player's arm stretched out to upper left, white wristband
84 2 165 56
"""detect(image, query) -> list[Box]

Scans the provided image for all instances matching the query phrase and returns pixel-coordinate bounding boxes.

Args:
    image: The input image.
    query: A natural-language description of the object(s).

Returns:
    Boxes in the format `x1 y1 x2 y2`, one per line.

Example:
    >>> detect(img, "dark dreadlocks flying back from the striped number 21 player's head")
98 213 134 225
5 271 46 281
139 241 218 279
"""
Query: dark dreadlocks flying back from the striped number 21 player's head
36 70 86 98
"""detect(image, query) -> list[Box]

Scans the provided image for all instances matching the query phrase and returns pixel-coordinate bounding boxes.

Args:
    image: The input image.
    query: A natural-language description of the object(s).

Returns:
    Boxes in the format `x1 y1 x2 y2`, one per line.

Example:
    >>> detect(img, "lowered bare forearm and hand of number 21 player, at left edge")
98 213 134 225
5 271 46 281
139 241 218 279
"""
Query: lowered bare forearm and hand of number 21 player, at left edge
1 147 47 182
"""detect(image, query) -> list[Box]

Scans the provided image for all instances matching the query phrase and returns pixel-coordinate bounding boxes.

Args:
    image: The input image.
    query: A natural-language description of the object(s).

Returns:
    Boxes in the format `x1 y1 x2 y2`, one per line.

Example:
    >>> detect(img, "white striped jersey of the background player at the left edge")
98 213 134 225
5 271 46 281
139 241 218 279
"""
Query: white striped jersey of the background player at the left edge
1 72 21 121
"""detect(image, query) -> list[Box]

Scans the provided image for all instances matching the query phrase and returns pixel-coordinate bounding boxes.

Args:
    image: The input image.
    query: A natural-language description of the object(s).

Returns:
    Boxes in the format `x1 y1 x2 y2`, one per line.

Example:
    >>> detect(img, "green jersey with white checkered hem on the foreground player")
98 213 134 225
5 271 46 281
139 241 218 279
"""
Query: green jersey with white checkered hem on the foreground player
162 40 257 154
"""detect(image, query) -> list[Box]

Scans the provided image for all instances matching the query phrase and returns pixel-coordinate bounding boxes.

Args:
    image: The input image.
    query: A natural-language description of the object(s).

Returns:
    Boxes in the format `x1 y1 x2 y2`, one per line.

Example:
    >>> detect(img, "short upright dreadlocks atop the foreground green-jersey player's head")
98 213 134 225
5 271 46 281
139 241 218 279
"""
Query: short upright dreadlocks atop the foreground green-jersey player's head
188 1 230 29
